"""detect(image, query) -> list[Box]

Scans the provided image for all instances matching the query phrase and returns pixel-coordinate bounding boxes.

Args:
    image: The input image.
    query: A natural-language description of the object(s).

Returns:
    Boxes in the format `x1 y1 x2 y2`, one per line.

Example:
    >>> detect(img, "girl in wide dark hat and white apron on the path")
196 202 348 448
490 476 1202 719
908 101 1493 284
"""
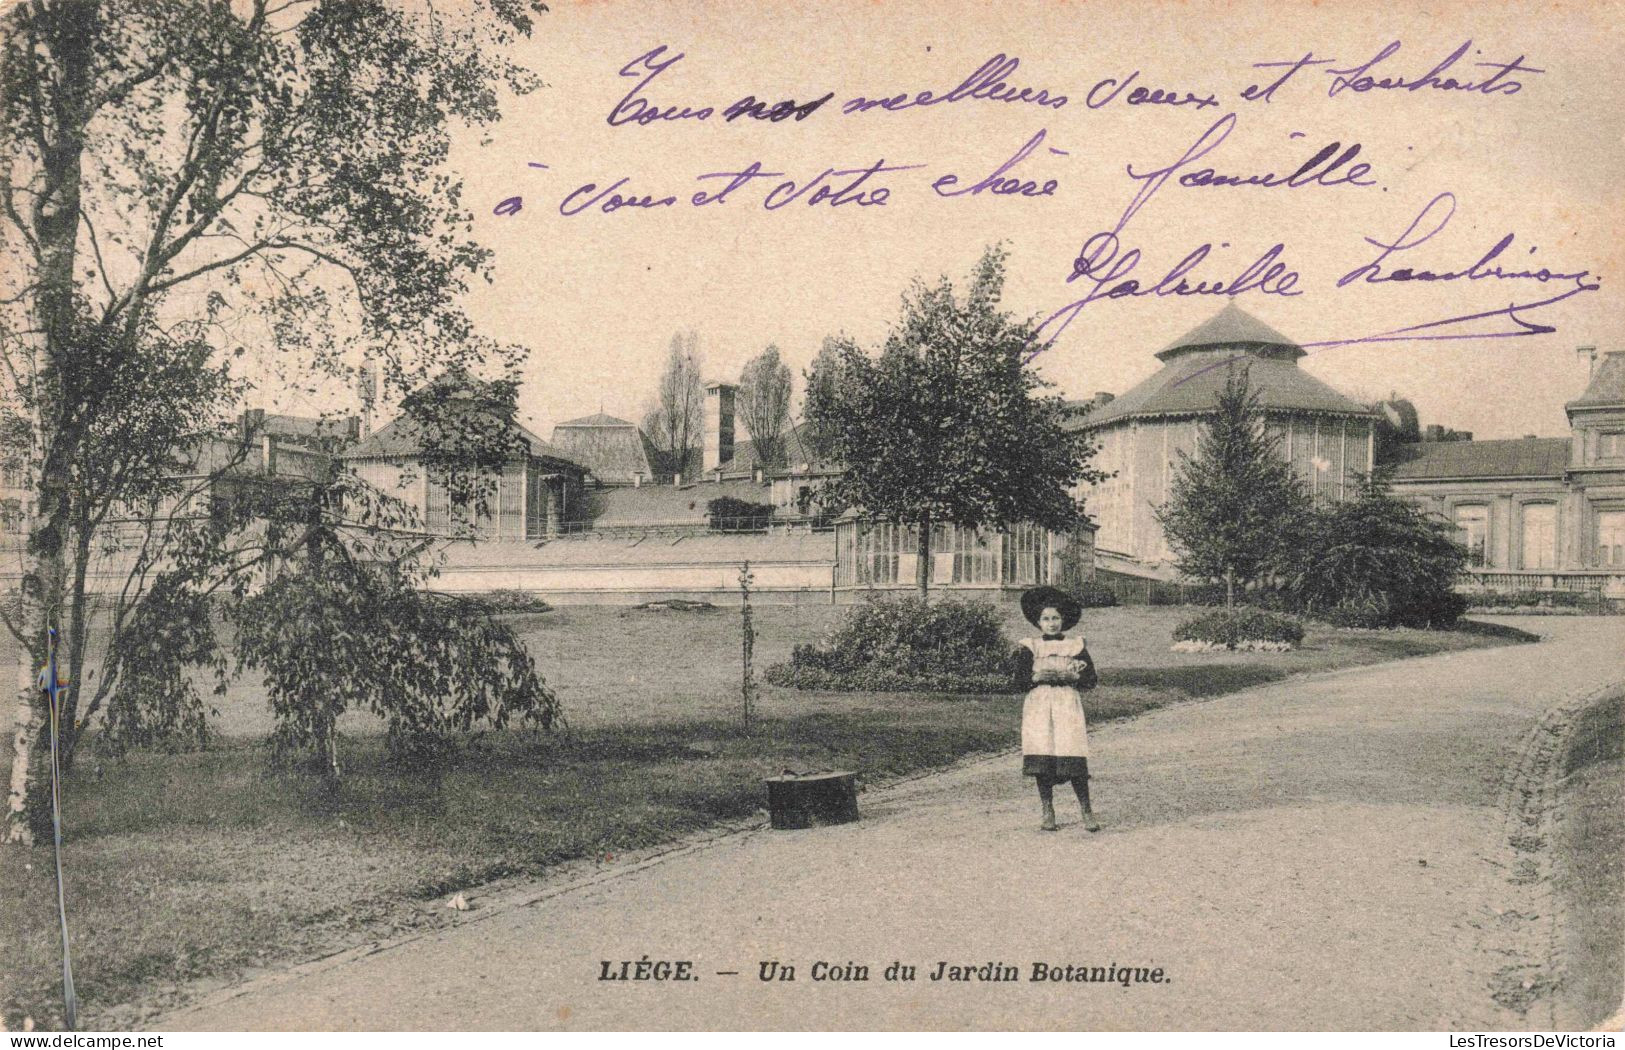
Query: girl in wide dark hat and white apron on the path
1014 587 1100 831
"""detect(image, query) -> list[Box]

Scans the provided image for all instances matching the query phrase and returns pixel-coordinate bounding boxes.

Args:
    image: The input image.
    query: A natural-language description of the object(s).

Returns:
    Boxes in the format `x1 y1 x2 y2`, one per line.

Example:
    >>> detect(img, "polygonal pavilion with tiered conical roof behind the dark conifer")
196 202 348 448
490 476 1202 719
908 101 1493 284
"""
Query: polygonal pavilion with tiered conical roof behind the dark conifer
1074 302 1376 579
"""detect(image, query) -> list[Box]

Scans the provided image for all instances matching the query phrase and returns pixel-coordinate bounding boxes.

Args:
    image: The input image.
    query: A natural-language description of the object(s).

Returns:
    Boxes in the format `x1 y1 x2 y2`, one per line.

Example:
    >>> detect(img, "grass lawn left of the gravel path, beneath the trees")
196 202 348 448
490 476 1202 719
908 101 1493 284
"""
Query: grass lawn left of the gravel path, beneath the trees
0 606 1528 1027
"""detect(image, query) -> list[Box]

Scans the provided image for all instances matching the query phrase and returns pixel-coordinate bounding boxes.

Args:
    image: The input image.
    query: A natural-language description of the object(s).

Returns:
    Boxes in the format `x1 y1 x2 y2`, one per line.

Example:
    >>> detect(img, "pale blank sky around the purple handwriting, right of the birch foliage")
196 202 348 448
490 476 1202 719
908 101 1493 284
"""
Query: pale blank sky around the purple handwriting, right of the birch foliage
326 0 1625 437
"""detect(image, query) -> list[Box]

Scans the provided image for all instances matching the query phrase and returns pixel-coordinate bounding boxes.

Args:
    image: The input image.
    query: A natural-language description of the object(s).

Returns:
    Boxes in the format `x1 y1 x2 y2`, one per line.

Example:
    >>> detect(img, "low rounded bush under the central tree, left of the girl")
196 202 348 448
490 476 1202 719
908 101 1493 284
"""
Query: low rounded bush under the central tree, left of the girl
765 595 1012 692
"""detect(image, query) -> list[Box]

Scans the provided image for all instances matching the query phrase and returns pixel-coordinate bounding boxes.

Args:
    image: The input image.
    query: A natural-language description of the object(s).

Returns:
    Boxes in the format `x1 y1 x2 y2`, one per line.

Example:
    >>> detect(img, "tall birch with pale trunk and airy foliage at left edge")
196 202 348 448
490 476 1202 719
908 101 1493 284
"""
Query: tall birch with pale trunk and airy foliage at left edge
0 0 544 840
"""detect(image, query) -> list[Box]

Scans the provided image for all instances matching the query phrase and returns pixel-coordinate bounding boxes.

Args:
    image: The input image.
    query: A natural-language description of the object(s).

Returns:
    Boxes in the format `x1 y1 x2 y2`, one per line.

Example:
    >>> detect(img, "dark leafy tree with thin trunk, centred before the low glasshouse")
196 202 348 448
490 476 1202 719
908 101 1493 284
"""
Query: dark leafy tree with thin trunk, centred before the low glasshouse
806 247 1103 592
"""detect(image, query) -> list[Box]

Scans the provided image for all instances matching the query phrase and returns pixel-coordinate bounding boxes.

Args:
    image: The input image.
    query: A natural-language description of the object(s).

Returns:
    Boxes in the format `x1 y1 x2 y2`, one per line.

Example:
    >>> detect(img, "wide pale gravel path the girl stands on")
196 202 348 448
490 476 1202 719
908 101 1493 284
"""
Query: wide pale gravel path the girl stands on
150 618 1625 1030
